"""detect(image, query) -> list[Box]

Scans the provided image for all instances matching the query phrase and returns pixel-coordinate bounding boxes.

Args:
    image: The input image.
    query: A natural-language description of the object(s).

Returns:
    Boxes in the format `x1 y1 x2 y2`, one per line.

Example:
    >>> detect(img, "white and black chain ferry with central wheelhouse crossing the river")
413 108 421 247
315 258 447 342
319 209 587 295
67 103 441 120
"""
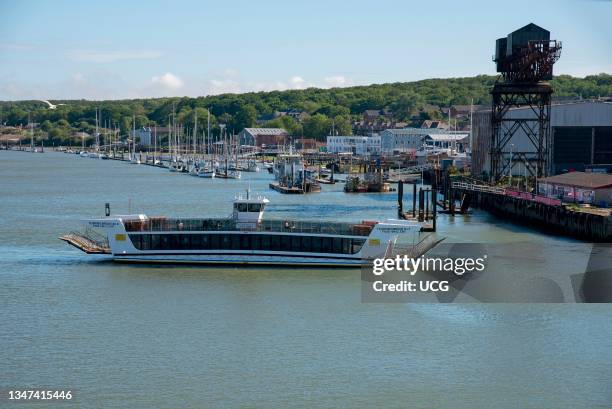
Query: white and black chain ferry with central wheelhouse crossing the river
60 192 430 267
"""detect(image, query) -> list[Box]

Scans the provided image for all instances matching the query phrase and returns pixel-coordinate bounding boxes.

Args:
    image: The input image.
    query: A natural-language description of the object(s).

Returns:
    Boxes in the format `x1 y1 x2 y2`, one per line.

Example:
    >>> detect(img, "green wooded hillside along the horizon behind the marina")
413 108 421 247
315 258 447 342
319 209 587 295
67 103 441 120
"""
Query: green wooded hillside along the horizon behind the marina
0 74 612 145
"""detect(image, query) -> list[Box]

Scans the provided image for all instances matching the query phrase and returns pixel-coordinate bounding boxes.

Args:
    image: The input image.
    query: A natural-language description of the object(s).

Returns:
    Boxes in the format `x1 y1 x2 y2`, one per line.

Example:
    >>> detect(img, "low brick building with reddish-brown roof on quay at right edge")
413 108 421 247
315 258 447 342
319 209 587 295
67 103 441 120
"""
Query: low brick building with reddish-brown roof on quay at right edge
538 172 612 207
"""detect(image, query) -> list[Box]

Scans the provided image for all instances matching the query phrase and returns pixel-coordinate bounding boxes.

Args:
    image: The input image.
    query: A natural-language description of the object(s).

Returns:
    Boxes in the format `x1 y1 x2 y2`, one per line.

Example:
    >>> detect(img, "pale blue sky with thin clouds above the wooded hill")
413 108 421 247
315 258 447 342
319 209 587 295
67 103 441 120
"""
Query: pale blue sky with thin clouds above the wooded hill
0 0 612 100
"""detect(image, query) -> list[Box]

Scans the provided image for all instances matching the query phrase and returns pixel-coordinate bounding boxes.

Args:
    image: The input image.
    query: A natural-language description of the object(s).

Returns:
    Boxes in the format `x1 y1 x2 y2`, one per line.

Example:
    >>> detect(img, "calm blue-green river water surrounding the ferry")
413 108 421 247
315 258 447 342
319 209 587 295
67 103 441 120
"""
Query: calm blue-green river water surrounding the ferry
0 151 612 408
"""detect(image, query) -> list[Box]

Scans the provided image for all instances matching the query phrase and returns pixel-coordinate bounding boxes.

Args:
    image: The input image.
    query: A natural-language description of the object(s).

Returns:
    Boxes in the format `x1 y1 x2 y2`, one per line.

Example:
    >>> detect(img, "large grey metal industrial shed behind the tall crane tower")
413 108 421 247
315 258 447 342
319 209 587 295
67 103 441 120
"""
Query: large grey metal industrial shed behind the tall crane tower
472 101 612 176
